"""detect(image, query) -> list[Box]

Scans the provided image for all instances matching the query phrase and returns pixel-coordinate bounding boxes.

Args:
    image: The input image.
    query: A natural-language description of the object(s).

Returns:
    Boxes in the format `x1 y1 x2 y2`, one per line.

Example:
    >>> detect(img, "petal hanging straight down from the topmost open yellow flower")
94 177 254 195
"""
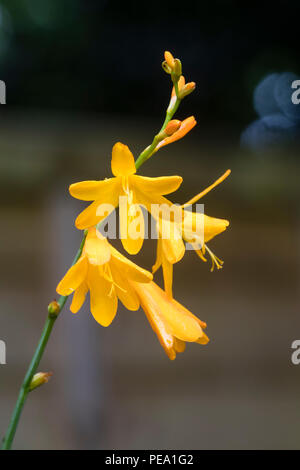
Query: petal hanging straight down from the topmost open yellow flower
120 203 145 255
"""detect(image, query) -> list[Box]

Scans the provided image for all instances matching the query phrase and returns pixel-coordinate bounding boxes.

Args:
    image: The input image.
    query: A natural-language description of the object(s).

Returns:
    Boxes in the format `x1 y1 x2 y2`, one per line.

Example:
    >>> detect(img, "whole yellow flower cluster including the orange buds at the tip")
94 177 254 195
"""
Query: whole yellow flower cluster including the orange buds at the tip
57 52 230 359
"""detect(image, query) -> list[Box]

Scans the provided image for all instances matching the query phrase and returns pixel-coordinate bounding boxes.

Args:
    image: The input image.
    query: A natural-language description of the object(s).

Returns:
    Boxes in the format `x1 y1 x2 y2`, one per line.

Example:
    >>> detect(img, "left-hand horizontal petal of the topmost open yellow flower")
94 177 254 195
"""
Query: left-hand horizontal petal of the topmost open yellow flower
69 178 117 202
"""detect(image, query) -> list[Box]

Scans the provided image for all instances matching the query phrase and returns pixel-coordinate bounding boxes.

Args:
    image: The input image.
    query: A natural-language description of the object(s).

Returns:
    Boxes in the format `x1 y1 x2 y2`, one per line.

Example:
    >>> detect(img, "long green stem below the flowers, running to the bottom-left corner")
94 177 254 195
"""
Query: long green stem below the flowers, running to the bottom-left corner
1 233 86 450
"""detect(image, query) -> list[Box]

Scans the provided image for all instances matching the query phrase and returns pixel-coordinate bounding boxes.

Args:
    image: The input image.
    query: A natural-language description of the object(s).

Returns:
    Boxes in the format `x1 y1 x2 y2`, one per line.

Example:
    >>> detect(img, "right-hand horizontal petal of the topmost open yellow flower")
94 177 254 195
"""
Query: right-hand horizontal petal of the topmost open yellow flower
130 175 182 197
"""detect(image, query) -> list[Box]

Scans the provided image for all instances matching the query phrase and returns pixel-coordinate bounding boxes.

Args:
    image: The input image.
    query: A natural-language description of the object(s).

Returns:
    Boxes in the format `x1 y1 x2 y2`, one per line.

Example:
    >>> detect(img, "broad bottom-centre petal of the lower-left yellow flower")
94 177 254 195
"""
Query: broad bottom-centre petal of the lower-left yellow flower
88 266 118 326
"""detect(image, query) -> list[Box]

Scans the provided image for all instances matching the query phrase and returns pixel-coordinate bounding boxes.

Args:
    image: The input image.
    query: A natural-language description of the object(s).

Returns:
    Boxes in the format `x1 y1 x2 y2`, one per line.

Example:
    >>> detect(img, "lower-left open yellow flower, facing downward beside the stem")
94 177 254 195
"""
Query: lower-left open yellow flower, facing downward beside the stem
56 228 153 326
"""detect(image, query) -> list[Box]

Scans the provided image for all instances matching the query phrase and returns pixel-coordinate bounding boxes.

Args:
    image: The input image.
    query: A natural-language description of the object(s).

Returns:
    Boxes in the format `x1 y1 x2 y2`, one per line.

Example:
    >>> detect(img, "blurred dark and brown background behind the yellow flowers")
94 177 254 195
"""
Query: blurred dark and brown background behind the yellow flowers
0 0 300 449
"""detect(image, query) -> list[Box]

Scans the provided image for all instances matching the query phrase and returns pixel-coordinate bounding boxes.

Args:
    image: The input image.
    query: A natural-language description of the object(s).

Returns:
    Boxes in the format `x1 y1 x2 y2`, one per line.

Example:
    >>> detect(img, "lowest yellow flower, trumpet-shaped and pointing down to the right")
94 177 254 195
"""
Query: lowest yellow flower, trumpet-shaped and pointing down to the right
132 282 209 360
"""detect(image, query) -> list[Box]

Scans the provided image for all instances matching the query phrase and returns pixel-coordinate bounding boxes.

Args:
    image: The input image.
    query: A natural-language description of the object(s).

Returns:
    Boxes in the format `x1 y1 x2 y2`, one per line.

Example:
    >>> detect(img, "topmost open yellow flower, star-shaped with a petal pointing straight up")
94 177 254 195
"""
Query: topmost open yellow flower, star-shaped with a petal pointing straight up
69 142 182 254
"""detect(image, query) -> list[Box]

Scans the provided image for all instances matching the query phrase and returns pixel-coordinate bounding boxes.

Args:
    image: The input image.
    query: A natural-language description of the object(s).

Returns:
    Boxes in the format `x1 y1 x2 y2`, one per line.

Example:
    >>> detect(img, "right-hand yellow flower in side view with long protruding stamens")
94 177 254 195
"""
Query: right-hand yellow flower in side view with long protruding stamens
152 170 230 297
